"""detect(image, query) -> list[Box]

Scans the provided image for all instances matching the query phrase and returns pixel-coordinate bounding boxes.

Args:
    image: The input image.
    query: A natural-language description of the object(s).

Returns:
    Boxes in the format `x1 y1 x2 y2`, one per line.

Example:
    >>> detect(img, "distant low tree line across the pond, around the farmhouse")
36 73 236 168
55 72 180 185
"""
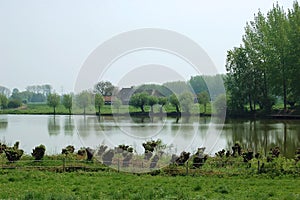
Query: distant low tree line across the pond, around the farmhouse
0 75 222 114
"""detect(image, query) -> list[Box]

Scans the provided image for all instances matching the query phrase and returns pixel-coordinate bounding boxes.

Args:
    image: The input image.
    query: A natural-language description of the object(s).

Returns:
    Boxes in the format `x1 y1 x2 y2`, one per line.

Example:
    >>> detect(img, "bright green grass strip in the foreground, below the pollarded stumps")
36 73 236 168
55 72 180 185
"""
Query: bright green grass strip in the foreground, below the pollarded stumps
0 170 300 200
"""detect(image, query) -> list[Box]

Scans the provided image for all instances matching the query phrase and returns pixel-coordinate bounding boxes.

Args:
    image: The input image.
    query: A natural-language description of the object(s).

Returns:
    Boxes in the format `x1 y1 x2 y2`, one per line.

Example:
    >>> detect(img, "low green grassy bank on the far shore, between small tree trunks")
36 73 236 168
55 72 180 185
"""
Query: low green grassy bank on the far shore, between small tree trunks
0 104 211 115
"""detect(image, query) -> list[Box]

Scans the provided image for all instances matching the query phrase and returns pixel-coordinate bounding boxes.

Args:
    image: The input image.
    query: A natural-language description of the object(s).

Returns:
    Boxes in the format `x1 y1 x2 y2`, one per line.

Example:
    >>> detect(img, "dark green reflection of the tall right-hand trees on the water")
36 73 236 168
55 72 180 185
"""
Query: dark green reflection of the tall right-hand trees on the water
224 120 300 157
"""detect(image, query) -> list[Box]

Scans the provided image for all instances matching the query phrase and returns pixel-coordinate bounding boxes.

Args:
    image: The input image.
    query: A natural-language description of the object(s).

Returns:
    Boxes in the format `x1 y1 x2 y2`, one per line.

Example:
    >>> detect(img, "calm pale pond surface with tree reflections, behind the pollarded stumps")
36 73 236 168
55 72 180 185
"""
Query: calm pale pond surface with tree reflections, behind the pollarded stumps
0 115 300 157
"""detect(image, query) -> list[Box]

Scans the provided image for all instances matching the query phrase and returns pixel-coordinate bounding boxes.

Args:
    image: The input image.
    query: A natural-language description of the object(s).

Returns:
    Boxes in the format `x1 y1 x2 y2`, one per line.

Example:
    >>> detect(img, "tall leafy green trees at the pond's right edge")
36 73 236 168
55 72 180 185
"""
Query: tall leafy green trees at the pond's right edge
225 1 300 113
